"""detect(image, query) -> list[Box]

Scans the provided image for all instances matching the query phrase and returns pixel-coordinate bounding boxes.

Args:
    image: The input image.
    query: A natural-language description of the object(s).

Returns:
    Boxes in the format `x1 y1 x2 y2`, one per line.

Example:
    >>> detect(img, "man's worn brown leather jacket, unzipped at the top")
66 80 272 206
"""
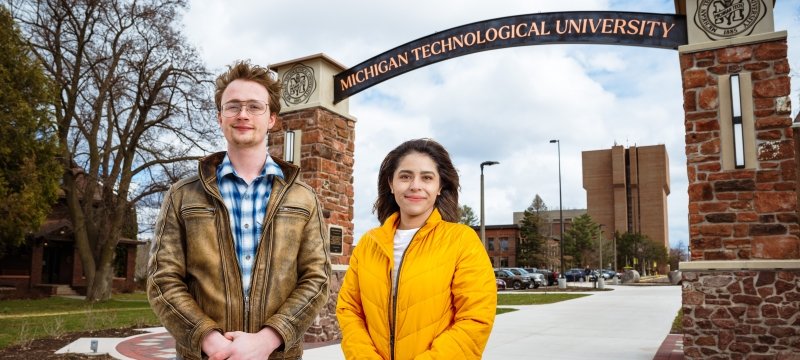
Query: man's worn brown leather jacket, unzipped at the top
147 153 331 359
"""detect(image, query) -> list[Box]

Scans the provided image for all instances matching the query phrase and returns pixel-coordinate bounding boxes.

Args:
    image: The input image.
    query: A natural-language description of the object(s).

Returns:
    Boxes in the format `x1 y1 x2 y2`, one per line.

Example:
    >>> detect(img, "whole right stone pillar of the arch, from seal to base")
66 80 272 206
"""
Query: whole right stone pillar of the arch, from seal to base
676 0 800 359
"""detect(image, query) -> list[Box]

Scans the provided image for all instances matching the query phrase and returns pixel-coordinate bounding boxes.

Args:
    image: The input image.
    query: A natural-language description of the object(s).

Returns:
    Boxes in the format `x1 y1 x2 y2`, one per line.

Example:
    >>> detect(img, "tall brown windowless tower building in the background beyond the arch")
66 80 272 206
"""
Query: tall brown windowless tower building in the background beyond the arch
582 145 669 248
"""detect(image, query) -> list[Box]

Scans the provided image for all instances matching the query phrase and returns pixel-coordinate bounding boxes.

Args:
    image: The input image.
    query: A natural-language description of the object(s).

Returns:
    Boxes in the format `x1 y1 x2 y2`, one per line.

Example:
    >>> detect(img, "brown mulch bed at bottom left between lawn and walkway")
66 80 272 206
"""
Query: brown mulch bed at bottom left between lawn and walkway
0 327 142 360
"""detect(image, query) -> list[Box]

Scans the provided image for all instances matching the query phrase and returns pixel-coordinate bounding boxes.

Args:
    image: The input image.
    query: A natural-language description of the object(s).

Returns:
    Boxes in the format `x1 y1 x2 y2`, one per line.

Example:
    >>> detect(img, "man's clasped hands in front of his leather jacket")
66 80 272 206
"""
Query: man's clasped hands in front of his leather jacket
206 326 283 360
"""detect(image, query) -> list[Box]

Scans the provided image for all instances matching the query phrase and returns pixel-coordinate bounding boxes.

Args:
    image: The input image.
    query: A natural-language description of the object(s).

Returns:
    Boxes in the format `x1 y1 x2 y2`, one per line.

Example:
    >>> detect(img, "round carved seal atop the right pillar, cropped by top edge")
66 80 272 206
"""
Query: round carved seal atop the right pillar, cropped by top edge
694 0 767 40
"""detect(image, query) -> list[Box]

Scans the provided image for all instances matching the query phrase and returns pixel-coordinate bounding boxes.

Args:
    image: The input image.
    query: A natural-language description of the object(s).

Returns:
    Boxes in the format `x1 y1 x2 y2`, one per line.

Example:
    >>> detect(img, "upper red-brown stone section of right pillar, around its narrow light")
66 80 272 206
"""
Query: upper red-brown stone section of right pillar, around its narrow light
680 39 800 261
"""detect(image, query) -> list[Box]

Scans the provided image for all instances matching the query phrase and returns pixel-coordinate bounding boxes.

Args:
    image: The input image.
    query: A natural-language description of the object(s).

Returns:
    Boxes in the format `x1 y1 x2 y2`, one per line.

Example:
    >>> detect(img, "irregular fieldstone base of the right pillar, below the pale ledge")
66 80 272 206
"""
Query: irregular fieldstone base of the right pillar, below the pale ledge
683 270 800 360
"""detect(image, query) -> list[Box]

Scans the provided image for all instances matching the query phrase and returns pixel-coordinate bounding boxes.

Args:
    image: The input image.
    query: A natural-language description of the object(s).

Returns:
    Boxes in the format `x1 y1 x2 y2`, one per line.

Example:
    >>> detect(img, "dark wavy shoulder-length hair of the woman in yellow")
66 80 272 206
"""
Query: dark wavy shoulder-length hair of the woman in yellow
372 139 461 223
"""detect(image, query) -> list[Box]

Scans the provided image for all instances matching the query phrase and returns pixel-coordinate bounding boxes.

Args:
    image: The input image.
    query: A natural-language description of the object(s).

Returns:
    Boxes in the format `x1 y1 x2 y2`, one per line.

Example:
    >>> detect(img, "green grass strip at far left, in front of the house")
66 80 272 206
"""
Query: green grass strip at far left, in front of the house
0 293 159 349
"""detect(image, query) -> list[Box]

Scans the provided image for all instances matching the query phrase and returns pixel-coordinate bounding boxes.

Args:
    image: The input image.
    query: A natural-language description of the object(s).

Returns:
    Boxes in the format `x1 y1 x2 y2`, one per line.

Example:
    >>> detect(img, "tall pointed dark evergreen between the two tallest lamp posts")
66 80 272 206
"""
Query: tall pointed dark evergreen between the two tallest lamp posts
517 194 547 267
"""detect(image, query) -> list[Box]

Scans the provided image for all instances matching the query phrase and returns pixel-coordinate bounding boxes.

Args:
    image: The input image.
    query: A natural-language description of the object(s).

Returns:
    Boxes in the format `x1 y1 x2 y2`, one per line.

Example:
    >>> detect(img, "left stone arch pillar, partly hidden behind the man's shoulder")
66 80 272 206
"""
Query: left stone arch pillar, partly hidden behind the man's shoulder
269 54 356 342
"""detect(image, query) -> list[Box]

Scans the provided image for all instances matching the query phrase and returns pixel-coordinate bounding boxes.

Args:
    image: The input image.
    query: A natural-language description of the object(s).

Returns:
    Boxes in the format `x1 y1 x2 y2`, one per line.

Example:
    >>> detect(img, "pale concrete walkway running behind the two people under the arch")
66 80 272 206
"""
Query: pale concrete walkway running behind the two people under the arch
57 283 683 360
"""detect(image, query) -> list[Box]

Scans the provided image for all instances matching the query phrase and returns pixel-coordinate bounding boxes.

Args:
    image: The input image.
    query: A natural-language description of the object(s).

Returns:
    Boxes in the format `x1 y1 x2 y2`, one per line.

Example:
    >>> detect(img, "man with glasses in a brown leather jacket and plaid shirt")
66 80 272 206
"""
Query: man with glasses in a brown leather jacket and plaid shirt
147 61 331 359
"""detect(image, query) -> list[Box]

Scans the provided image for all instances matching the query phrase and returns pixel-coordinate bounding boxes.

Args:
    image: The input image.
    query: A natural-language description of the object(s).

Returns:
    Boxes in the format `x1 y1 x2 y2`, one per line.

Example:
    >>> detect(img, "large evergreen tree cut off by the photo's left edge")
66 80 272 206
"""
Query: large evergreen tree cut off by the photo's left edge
0 6 63 256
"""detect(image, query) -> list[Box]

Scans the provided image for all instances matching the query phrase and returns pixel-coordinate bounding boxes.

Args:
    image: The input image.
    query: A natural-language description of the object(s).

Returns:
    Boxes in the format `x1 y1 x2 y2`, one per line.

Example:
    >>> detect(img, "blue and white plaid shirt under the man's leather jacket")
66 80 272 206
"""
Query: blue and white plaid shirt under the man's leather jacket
217 154 283 296
